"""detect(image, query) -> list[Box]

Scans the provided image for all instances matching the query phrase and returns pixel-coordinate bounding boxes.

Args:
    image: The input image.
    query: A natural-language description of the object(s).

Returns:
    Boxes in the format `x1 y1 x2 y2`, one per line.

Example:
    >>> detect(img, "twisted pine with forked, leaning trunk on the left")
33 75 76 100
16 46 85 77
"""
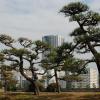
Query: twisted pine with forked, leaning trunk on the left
0 34 50 94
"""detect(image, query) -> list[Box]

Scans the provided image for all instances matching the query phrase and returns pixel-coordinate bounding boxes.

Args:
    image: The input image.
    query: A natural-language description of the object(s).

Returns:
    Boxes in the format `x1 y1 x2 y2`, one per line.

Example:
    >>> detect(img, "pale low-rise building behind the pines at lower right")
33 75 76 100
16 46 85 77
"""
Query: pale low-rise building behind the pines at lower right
59 68 99 88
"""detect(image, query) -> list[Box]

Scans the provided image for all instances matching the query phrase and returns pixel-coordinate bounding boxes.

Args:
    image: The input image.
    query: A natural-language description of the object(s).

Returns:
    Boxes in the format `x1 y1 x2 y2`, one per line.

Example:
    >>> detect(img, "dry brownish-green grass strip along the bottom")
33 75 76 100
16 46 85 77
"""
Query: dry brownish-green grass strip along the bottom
0 92 100 100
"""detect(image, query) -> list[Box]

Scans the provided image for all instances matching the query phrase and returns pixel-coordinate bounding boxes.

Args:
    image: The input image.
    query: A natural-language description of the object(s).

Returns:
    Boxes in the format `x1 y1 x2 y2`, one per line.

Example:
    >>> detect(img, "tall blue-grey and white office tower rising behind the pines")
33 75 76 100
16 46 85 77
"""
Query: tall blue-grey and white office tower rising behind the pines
42 35 64 87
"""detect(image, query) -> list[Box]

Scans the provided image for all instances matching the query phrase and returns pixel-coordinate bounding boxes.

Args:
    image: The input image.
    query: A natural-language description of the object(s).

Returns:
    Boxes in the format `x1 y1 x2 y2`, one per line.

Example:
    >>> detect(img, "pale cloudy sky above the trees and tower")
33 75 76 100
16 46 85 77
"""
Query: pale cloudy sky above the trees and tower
0 0 100 41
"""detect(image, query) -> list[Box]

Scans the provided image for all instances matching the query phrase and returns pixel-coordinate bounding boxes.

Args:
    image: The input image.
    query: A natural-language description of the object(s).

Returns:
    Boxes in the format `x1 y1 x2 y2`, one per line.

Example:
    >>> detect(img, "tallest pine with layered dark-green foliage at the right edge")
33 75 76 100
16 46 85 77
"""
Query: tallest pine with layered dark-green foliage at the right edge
60 2 100 73
